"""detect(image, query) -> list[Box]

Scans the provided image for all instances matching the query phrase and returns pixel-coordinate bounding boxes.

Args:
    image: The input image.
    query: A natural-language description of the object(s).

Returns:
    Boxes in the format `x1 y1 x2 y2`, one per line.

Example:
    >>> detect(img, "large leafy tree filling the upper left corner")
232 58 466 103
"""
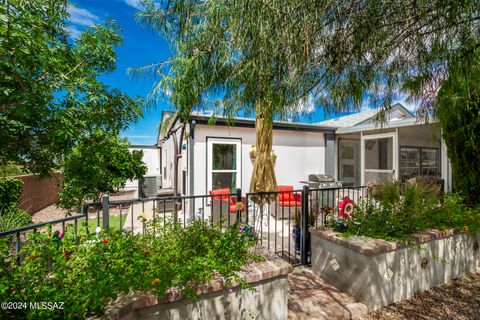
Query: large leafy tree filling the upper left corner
0 0 141 175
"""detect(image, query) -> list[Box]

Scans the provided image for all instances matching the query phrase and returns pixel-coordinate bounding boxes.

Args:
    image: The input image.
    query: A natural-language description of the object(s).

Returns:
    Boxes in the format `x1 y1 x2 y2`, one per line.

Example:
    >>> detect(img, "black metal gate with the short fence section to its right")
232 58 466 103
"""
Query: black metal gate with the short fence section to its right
246 186 365 266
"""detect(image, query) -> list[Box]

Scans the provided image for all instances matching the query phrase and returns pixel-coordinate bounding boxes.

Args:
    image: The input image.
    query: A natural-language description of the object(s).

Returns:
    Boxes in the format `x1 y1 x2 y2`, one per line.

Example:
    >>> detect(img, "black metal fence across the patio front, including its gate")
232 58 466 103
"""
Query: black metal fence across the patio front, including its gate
0 187 366 265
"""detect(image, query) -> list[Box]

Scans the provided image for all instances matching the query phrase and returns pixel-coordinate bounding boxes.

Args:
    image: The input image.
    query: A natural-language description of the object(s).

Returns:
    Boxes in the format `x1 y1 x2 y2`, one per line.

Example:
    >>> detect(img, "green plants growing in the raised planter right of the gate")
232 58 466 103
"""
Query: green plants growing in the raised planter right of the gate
338 180 480 242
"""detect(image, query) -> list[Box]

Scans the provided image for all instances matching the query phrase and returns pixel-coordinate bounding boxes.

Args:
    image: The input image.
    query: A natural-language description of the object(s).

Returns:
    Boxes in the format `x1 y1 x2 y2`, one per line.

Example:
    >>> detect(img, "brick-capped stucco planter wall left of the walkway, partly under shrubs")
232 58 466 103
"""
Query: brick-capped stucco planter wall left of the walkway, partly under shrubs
106 253 292 320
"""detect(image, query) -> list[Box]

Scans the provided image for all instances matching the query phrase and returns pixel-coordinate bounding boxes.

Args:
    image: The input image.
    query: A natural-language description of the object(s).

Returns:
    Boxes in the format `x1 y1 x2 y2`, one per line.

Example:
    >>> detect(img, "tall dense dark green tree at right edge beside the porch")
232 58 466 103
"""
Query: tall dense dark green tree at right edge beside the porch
436 41 480 204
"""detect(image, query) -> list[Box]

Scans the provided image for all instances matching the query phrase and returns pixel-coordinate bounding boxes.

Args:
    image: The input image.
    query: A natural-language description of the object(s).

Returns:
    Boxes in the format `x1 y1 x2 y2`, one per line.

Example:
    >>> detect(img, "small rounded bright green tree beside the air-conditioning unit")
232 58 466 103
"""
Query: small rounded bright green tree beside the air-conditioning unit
59 130 147 208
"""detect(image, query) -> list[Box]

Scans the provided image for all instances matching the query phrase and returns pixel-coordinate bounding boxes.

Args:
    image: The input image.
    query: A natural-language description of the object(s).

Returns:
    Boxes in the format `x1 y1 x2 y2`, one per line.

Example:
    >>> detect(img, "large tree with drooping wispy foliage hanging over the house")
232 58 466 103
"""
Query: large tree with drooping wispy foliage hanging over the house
136 0 480 192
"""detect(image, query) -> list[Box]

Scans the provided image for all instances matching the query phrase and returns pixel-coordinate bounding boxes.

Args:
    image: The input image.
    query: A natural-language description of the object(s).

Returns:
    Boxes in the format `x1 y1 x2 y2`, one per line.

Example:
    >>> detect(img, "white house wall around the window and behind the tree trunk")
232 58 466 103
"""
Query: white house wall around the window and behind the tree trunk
193 125 325 195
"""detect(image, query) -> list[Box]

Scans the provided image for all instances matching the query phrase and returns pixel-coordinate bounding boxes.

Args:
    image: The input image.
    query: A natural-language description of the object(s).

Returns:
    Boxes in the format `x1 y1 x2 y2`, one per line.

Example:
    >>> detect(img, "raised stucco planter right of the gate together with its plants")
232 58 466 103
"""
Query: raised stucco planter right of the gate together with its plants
310 181 480 310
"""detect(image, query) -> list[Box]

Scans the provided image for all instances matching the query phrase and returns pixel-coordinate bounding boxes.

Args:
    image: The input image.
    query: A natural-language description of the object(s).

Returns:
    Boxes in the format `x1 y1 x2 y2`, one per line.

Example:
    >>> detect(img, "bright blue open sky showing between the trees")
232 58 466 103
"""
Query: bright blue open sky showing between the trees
68 0 408 145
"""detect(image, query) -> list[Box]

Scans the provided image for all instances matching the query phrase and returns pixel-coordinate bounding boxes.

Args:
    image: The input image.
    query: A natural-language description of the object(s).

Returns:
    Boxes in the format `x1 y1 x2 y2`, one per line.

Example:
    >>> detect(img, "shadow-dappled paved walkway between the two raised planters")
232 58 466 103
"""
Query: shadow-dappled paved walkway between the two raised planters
288 267 367 320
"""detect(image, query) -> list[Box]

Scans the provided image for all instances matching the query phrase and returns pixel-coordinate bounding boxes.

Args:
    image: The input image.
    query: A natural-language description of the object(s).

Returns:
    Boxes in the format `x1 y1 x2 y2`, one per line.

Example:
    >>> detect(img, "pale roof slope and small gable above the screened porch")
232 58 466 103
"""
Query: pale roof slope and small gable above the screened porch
316 103 415 128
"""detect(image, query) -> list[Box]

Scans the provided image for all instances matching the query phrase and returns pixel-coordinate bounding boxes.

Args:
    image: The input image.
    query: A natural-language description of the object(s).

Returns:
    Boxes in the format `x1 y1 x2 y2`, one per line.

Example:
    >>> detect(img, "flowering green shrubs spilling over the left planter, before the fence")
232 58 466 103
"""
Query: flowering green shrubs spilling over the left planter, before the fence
0 220 257 319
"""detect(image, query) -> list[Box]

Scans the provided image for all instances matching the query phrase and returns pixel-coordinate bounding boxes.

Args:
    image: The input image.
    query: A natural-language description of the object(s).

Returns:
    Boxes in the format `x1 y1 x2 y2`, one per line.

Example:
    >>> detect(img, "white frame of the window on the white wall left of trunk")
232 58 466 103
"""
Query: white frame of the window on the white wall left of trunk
207 138 242 192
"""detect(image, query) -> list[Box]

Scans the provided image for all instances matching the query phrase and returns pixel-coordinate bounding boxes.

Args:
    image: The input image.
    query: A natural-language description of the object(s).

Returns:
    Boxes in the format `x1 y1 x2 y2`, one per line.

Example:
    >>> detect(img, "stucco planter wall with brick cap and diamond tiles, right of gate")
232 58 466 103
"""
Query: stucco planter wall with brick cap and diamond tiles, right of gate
310 229 480 311
